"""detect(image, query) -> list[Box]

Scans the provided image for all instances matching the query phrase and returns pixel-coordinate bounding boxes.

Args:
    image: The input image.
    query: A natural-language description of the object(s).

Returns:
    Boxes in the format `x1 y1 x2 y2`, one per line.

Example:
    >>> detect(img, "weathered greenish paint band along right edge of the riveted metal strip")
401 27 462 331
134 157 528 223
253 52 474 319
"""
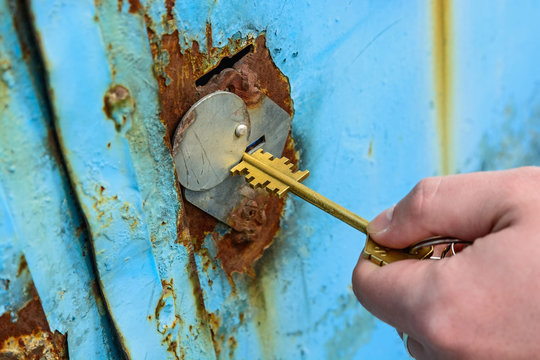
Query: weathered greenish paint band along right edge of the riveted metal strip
97 2 214 359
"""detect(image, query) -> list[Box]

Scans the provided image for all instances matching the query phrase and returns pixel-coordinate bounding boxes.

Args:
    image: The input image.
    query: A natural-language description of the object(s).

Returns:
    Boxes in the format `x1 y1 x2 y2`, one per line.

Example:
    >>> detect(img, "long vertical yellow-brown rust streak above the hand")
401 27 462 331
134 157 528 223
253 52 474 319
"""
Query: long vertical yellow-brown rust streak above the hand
432 0 454 174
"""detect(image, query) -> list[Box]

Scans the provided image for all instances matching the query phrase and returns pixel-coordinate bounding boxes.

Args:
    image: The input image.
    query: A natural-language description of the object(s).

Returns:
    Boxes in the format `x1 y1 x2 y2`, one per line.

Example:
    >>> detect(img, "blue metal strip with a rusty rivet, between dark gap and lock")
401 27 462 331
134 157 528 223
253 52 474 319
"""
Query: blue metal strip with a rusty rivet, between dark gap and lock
26 1 213 359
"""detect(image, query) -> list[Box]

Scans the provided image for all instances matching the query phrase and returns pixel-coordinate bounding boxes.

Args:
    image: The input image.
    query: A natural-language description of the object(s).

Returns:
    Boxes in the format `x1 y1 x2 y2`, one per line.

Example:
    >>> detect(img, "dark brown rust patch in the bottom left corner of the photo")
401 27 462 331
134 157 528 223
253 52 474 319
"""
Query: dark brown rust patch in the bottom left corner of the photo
0 286 68 360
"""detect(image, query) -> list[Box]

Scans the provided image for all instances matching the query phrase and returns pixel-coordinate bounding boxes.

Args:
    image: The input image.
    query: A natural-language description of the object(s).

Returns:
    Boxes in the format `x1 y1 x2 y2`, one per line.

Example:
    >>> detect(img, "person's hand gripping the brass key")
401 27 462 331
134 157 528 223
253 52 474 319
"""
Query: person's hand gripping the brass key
352 167 540 359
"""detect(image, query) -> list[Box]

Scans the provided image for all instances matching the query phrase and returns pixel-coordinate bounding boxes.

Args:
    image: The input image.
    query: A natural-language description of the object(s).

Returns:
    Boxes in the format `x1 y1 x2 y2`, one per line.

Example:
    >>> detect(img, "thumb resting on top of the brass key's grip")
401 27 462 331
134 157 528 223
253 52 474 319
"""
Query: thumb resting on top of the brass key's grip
368 170 516 248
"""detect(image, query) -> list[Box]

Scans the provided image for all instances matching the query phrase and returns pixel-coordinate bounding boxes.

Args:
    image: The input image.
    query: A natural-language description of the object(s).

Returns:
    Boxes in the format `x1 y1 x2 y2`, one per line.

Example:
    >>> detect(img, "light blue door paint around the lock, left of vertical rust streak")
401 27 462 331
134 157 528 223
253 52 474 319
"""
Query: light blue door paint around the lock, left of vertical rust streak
142 1 437 359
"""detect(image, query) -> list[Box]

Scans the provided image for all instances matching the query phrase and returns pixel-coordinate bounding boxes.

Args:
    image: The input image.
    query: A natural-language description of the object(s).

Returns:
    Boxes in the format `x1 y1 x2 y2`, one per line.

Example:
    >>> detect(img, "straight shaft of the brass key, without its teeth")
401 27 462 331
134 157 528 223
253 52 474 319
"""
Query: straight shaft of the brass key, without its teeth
242 153 369 235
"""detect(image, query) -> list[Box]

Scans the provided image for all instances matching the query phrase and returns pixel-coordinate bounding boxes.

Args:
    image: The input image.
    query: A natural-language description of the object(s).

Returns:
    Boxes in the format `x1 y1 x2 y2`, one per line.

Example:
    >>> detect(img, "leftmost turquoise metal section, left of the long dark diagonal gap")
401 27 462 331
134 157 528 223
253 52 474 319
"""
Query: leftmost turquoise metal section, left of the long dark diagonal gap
0 1 118 359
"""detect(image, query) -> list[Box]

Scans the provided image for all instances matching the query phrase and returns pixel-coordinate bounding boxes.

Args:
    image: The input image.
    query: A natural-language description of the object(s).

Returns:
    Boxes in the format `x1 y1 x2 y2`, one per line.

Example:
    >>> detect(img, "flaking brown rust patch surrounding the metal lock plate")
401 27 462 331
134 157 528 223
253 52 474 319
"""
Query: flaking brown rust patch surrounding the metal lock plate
146 16 297 279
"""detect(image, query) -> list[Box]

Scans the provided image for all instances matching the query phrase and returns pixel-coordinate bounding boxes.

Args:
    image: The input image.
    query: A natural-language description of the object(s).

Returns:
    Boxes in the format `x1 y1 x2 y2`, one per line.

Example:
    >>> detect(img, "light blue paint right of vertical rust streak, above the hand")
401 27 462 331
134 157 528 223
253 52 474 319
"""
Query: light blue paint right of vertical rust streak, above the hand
453 0 540 172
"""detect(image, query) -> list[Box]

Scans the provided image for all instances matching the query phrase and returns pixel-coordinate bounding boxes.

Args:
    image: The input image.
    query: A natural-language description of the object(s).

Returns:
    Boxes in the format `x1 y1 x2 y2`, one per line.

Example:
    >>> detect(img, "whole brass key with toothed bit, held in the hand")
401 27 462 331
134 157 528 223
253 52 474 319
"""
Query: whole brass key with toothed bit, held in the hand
230 149 433 266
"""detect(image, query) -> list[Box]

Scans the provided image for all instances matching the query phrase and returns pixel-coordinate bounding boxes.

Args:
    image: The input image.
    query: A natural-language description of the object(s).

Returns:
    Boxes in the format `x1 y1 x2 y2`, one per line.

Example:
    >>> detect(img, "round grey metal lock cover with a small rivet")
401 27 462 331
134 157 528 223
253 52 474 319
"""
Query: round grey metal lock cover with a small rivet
173 91 251 191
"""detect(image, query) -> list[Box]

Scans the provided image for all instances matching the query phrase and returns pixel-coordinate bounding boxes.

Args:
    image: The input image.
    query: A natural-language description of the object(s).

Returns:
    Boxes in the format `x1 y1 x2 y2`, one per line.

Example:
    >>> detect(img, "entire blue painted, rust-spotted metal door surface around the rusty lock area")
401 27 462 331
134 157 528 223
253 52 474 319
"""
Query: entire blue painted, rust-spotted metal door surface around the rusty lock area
0 0 540 359
